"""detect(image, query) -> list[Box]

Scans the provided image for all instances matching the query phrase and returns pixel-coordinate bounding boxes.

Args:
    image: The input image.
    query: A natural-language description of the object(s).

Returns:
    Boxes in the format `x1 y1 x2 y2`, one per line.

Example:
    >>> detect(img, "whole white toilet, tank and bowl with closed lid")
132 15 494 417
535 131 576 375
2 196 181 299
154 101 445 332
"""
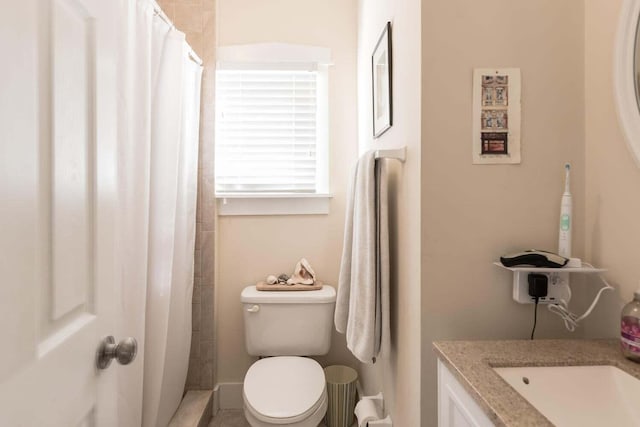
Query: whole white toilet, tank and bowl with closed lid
240 286 336 427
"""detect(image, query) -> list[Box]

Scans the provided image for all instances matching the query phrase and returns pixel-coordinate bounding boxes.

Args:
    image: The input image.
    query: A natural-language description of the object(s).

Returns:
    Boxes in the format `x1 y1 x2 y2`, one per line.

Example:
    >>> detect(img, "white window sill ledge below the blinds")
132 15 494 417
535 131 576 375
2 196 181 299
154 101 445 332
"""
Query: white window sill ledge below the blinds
216 193 333 216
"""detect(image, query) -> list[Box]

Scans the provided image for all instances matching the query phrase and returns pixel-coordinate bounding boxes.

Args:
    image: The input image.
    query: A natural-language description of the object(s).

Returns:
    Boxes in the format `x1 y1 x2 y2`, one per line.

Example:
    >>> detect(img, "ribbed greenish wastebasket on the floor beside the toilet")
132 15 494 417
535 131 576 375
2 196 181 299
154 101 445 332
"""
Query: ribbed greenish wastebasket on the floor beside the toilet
324 365 358 427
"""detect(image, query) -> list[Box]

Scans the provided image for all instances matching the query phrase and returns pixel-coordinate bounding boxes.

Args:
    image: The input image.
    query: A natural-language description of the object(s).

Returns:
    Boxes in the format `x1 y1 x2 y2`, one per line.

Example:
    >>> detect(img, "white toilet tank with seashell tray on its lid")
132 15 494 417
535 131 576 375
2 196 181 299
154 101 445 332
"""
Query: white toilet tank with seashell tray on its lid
240 285 336 356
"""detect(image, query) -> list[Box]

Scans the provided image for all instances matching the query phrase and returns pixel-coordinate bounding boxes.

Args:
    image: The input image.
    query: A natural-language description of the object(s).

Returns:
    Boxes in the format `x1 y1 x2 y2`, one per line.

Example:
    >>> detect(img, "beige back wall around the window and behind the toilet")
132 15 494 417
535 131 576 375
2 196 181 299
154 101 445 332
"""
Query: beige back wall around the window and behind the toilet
216 0 358 382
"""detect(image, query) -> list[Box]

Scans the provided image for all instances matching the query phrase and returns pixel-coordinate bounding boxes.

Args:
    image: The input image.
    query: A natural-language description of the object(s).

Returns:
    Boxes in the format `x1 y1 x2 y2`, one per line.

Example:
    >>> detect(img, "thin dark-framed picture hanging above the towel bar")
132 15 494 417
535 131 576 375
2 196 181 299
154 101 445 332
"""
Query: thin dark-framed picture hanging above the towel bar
371 22 393 138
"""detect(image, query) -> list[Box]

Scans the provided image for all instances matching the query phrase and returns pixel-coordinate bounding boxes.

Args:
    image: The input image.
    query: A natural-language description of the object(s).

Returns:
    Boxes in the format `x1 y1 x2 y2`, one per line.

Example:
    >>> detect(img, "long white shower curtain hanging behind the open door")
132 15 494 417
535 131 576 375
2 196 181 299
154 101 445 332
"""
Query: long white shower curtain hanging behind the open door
118 0 202 427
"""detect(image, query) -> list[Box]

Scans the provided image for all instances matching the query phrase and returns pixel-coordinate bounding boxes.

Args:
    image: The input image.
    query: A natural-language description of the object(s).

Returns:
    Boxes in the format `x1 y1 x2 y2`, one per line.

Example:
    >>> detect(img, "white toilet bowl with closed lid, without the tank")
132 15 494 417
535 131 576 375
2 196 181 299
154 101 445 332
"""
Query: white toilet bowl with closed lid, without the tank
243 356 327 425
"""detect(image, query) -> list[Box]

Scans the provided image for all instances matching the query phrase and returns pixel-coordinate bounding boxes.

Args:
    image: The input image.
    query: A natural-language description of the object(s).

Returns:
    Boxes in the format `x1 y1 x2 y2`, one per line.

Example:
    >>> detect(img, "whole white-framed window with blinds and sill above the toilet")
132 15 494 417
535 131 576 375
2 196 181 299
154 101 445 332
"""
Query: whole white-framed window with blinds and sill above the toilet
215 45 328 215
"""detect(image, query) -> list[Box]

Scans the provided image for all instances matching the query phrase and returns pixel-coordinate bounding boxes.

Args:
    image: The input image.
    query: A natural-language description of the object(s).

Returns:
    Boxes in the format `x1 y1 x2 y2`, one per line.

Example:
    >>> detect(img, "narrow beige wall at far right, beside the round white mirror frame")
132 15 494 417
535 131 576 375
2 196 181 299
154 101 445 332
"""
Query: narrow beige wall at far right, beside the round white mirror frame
585 0 640 337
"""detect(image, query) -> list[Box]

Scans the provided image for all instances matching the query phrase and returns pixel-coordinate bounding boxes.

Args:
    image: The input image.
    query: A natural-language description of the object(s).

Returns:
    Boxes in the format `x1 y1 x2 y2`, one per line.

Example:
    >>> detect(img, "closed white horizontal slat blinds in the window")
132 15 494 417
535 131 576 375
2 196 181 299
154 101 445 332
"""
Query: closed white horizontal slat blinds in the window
216 69 318 194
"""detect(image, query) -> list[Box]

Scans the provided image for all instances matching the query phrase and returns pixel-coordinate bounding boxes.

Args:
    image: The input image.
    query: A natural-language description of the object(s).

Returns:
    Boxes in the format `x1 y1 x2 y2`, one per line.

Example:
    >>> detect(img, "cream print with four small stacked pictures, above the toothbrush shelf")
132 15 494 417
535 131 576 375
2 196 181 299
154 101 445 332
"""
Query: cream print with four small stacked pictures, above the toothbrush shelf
472 68 521 164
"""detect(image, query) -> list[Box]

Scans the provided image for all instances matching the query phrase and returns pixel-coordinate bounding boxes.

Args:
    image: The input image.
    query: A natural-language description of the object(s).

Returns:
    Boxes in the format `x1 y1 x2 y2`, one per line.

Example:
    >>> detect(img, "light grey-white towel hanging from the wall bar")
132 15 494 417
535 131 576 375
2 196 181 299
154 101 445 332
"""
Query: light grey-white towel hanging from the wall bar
334 151 390 363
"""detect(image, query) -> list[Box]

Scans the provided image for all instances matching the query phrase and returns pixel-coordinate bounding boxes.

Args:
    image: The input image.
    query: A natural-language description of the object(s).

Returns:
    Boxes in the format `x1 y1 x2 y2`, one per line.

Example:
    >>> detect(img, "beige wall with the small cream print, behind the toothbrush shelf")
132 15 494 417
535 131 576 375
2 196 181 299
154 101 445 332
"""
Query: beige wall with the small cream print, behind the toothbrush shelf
421 0 584 426
